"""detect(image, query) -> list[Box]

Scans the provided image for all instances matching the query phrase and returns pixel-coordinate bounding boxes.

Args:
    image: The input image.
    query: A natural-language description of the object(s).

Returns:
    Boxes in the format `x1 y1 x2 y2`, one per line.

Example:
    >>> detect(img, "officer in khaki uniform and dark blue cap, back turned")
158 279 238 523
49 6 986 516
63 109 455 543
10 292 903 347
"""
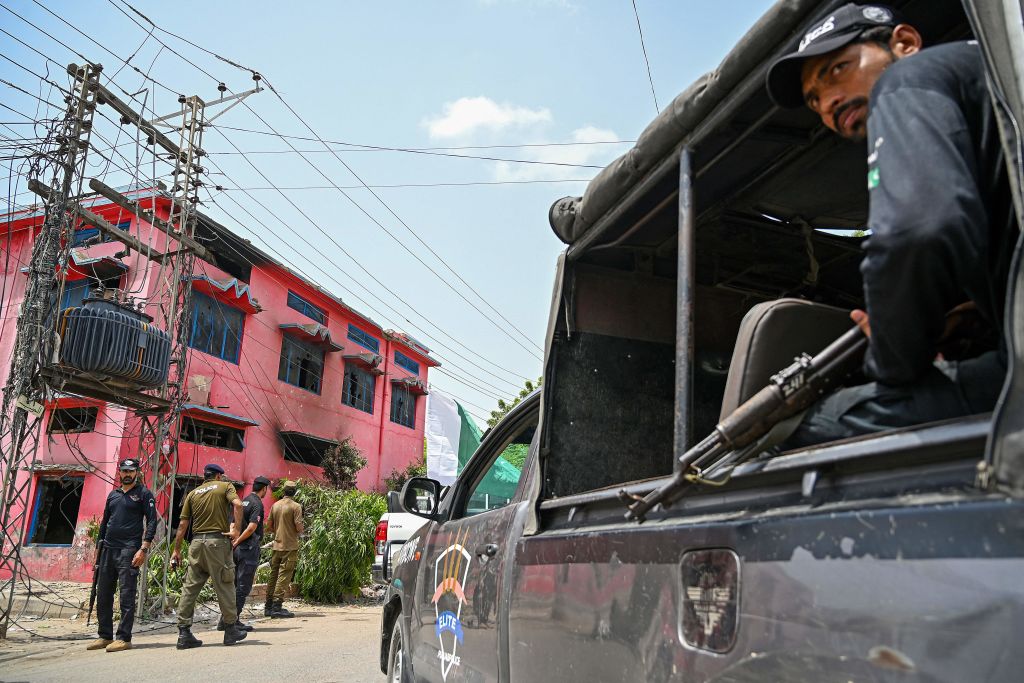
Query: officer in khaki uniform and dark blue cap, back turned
171 464 249 650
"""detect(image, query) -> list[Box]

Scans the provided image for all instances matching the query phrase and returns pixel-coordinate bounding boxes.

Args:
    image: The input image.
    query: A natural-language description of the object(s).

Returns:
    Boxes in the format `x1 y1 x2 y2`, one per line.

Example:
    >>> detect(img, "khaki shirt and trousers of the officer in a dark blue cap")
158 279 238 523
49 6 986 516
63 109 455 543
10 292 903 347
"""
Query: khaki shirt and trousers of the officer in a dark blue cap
178 480 239 627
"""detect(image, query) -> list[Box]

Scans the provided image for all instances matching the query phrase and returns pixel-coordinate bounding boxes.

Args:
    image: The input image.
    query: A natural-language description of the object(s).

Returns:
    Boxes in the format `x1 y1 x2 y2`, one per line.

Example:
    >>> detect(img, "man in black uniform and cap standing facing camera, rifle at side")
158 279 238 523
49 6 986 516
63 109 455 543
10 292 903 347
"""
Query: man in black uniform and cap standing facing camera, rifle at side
86 458 157 652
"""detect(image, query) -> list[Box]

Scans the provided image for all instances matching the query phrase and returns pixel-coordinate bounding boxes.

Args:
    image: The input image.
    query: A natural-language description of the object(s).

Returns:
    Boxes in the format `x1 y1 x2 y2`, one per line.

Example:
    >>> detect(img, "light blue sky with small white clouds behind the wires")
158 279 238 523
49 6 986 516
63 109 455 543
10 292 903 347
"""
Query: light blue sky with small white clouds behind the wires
0 0 772 422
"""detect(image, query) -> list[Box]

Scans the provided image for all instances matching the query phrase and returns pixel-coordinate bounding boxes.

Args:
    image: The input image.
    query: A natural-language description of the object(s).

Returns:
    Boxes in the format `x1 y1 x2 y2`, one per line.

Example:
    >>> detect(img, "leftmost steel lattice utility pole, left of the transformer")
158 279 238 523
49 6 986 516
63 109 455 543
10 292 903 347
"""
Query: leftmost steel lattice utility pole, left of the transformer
0 63 102 639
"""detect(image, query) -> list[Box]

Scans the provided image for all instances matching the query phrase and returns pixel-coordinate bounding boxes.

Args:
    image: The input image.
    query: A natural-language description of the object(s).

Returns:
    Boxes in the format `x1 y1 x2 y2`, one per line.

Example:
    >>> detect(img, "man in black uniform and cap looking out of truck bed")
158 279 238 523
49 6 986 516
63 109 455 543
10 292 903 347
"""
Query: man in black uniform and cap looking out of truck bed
767 4 1018 447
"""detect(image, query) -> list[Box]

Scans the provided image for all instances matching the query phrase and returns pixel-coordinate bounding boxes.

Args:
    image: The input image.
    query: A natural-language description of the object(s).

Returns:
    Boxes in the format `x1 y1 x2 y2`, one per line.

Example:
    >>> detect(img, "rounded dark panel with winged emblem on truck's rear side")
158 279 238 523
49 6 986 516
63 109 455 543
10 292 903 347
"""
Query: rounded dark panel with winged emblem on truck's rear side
681 548 739 652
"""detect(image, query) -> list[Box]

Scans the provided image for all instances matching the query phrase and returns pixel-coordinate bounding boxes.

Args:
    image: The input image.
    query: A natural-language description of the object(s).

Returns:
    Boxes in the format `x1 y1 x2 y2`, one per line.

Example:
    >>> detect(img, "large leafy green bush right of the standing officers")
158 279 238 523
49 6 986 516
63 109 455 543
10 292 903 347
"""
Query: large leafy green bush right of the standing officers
295 481 387 602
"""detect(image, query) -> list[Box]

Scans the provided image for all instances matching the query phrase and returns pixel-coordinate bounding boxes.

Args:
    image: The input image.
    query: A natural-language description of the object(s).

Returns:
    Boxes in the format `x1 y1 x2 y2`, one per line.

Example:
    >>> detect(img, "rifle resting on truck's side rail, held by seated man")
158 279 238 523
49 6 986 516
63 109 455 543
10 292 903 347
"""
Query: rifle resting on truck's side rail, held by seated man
618 327 867 522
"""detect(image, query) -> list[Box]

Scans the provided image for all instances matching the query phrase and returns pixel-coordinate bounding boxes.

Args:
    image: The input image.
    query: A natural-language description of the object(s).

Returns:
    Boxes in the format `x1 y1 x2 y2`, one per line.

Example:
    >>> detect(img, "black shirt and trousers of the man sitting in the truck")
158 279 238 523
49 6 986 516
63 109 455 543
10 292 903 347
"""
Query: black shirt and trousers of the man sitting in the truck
787 42 1019 446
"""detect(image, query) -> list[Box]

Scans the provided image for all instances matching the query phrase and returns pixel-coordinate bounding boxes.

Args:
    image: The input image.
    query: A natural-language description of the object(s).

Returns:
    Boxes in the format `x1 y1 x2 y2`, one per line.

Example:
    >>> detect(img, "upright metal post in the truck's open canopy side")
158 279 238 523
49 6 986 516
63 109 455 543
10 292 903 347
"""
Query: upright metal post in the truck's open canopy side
672 145 696 471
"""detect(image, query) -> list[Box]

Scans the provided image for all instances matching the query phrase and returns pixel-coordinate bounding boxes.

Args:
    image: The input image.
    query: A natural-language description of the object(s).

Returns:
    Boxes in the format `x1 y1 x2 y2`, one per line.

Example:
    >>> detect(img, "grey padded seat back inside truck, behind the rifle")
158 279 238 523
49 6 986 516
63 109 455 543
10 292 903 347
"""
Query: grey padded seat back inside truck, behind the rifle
719 299 853 420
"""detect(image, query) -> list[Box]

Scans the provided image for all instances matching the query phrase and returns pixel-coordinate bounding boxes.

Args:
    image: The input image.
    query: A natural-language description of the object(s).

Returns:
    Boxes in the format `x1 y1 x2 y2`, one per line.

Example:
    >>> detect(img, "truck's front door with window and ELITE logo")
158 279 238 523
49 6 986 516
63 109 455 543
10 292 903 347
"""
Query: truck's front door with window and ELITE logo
413 400 539 682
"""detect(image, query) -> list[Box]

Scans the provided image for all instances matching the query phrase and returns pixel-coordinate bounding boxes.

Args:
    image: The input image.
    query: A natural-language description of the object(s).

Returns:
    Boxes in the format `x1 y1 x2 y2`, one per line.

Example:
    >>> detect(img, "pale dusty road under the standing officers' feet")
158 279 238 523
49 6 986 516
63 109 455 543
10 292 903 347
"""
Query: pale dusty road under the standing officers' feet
0 604 384 683
